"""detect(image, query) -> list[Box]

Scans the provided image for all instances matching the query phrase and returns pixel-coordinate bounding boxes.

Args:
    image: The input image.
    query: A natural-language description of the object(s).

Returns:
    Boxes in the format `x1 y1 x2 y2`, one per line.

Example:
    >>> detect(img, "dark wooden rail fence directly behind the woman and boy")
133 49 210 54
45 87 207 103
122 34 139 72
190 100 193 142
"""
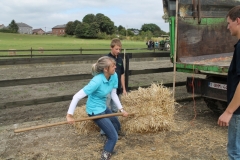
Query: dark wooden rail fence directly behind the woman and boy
0 52 186 108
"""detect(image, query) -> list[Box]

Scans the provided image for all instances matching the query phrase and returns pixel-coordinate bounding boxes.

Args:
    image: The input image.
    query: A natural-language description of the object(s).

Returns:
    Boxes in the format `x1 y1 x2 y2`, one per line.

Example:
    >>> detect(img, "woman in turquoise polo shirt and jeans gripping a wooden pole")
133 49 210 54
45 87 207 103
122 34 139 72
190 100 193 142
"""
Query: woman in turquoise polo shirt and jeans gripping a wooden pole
66 56 128 160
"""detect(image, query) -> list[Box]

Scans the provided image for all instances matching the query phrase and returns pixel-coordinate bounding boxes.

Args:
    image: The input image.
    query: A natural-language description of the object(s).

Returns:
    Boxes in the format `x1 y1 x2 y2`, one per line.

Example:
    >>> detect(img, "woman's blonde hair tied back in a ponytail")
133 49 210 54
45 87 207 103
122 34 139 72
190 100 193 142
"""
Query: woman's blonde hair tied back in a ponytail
92 56 116 76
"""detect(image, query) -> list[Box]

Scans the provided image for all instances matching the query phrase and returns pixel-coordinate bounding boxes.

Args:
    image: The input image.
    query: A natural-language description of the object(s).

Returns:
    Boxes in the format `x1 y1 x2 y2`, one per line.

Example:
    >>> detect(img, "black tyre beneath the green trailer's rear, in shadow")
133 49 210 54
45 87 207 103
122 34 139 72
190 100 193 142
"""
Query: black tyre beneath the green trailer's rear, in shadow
204 98 227 116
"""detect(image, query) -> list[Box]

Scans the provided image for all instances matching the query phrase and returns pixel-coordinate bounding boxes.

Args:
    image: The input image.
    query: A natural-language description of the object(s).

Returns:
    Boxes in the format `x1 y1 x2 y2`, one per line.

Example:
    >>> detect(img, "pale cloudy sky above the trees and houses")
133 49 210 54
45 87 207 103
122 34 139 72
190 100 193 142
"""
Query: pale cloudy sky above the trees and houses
0 0 169 32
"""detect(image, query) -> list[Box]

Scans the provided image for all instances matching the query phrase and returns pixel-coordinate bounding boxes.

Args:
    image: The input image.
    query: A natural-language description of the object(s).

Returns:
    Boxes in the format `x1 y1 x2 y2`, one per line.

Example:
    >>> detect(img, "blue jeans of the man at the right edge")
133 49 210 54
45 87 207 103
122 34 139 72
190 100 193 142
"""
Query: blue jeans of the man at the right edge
227 114 240 160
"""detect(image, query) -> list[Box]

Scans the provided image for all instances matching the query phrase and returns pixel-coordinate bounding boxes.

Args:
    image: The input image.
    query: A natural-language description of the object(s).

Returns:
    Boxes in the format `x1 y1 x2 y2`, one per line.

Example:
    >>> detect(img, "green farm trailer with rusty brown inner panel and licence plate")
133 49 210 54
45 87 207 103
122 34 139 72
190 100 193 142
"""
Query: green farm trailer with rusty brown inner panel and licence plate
163 0 240 113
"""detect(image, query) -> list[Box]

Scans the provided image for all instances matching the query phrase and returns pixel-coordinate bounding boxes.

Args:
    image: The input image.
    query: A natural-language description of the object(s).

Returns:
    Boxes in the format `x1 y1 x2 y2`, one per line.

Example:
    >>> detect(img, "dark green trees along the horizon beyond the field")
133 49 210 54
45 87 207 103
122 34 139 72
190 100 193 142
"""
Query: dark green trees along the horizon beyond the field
0 13 168 40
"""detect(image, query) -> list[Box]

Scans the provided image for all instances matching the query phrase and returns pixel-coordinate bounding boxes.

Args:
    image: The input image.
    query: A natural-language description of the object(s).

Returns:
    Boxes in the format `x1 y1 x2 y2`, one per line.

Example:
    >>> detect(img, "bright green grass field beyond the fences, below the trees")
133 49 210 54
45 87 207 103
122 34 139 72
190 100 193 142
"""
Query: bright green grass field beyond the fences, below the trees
0 33 150 55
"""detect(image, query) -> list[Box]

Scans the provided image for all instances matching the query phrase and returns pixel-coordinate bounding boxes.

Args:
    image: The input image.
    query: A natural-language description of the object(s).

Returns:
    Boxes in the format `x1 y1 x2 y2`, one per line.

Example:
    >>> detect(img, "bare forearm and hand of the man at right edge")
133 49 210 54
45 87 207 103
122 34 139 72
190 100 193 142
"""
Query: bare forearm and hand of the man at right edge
218 83 240 126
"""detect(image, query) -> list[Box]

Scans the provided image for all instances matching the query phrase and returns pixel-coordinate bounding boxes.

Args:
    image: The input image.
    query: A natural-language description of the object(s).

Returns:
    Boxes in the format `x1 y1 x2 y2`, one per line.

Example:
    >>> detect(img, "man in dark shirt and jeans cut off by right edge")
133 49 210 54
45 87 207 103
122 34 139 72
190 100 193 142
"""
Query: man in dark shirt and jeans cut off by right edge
218 5 240 160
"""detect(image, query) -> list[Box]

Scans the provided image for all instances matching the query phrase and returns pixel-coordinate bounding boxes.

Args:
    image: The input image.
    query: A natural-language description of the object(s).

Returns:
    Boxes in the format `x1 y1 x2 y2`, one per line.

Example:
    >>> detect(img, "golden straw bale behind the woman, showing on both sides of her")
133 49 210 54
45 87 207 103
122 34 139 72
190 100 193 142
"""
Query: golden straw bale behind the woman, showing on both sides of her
74 83 175 134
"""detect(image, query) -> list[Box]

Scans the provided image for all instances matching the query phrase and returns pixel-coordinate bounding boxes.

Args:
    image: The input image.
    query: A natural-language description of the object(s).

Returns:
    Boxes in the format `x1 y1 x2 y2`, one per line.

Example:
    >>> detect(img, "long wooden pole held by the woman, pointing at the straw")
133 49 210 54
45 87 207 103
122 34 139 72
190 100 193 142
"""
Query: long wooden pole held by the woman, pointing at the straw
14 113 134 133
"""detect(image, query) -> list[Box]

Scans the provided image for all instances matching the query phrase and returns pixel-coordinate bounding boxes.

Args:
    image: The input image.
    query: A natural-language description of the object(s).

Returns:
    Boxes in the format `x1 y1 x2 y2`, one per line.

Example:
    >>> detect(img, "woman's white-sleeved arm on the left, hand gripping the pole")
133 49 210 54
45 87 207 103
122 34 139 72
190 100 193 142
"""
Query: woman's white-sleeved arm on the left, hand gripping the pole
66 89 87 123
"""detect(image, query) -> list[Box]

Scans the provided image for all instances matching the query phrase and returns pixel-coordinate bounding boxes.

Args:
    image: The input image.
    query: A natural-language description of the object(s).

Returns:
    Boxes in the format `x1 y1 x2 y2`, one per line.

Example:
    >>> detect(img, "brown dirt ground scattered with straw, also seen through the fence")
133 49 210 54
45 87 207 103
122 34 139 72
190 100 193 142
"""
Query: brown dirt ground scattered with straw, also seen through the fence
0 60 227 160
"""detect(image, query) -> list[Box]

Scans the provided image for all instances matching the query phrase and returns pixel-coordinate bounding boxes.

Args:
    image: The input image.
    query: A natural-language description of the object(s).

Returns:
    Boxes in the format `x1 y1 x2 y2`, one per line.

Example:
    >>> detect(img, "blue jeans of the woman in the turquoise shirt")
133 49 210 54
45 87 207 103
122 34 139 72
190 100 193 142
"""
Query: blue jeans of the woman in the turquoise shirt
88 108 121 153
